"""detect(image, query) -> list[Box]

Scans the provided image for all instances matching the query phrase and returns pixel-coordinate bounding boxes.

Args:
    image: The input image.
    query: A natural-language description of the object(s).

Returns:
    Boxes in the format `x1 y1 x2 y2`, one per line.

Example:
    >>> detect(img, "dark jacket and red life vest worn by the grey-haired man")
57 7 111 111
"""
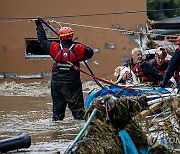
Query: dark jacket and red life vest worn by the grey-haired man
124 59 163 83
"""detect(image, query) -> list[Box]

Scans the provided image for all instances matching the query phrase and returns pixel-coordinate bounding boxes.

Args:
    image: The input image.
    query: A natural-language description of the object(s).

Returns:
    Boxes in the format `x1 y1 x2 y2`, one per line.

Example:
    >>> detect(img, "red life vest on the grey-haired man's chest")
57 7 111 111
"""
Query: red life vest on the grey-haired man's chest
130 62 154 83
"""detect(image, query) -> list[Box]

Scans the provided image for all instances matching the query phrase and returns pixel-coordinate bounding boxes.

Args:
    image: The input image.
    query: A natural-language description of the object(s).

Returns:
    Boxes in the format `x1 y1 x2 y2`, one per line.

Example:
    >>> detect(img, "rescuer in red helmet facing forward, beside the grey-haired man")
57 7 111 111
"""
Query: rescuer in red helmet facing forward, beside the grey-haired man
149 47 169 75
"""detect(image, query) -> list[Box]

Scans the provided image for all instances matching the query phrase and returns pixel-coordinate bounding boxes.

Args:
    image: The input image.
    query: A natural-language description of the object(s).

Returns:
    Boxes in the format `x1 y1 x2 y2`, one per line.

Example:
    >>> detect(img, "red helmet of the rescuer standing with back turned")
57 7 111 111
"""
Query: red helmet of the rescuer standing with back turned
58 27 74 40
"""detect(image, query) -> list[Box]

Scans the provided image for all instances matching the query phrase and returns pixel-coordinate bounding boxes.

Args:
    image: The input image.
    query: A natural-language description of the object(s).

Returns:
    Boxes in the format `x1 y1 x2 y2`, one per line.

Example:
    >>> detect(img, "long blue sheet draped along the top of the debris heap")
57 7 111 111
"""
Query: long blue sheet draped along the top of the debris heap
85 85 169 110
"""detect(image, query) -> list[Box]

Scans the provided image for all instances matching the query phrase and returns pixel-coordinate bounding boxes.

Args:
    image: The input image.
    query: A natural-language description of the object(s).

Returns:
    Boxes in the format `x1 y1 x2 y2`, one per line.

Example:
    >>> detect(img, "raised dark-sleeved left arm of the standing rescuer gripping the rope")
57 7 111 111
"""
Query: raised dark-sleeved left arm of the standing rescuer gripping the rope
35 18 51 54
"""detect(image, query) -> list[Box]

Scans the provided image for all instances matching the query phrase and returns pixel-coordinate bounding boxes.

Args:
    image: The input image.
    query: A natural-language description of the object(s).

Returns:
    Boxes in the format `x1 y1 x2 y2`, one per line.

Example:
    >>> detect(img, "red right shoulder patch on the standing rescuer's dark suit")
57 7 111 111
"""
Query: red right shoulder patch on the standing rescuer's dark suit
74 43 85 60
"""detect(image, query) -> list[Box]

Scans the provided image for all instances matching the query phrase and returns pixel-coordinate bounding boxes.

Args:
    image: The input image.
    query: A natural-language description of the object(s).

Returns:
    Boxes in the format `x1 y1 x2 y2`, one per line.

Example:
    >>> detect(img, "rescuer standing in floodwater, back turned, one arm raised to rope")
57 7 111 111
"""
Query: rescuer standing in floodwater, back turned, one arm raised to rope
35 18 94 121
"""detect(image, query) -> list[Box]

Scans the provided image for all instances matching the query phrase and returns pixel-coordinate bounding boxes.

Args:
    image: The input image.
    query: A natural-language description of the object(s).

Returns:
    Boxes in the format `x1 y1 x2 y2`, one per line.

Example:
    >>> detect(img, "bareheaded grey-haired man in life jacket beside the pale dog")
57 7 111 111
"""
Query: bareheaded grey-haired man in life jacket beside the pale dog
120 48 163 84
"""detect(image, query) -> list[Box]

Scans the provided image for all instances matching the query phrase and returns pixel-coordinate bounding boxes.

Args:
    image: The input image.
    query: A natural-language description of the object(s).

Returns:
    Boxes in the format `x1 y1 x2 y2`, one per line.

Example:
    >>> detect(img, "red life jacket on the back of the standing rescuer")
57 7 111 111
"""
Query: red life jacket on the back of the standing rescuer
50 42 78 70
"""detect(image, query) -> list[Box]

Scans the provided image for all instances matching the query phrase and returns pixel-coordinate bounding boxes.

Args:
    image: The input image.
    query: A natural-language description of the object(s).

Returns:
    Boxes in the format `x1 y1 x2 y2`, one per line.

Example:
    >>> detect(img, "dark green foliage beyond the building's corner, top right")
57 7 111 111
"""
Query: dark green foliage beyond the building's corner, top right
147 0 180 20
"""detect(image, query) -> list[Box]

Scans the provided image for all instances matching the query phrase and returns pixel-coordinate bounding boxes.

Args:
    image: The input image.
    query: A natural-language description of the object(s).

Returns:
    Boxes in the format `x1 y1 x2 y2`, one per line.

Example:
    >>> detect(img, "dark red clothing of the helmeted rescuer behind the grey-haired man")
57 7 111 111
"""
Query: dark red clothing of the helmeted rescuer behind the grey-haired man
149 59 169 75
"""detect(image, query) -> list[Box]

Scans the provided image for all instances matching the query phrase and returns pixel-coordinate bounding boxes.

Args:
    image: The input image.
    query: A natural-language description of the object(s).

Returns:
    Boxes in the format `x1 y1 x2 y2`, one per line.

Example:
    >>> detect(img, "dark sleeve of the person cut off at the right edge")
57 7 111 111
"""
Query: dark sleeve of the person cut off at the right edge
161 47 180 89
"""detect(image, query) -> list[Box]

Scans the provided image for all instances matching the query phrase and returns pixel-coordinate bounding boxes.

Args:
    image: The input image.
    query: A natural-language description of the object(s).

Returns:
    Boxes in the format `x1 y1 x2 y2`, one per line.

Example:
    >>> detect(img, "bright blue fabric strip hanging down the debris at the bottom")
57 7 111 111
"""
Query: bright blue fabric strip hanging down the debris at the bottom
118 129 138 154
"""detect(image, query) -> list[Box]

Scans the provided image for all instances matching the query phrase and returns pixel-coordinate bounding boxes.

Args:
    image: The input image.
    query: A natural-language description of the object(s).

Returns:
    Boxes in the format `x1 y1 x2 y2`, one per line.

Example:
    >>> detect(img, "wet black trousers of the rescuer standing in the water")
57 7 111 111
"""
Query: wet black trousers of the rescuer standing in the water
51 80 85 121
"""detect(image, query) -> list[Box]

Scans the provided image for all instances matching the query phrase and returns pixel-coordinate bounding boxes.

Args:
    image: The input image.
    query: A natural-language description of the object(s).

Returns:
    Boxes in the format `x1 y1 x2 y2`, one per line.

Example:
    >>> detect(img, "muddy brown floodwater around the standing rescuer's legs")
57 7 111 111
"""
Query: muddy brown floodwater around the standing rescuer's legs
0 82 98 154
